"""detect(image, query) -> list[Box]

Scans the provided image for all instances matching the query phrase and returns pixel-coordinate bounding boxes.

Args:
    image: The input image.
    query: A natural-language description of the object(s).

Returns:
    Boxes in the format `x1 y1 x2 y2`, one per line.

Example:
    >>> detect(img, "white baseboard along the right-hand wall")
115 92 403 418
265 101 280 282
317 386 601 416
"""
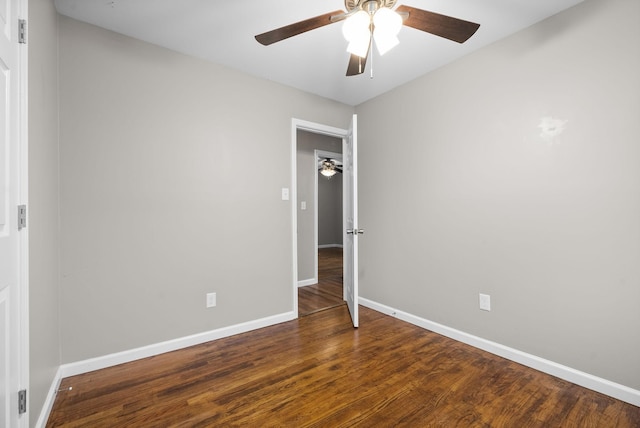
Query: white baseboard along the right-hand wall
358 297 640 406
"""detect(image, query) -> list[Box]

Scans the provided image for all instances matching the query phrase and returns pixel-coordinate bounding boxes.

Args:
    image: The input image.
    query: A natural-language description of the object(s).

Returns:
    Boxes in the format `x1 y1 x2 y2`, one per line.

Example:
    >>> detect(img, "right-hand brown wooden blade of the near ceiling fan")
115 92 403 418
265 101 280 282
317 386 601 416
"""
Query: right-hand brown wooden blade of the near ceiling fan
396 5 480 43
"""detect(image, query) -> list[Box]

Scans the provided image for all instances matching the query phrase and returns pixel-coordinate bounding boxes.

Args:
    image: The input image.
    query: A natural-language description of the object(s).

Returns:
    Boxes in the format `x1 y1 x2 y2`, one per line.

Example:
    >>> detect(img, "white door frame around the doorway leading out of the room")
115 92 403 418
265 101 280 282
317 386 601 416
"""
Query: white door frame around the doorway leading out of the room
290 118 349 318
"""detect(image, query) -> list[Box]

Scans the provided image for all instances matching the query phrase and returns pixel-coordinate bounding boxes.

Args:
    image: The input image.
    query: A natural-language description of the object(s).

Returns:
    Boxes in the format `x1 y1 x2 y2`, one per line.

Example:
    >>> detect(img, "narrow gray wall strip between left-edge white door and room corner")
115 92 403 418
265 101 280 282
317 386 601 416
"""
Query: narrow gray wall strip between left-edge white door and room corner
28 0 60 426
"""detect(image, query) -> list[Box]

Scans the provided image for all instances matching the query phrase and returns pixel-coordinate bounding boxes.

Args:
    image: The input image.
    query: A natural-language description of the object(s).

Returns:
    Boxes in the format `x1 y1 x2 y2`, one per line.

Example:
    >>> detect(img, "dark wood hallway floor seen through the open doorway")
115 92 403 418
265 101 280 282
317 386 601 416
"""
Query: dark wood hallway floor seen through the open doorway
298 248 345 317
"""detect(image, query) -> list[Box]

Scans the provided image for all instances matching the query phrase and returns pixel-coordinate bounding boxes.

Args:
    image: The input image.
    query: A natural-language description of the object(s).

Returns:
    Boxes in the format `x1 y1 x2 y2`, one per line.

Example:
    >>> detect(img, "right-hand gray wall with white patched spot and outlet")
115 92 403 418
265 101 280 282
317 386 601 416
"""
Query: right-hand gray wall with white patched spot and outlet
356 0 640 389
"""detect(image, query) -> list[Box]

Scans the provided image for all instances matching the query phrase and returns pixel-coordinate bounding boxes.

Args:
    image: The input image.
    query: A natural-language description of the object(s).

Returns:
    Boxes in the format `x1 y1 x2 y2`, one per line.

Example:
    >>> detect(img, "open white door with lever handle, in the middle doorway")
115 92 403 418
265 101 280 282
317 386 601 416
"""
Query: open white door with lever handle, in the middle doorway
342 114 363 327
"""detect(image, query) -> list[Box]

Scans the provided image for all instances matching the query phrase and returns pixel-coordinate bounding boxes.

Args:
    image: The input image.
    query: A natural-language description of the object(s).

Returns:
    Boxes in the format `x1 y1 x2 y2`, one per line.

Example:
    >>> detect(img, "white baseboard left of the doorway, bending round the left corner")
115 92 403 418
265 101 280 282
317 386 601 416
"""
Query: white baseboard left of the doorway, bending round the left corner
35 311 297 428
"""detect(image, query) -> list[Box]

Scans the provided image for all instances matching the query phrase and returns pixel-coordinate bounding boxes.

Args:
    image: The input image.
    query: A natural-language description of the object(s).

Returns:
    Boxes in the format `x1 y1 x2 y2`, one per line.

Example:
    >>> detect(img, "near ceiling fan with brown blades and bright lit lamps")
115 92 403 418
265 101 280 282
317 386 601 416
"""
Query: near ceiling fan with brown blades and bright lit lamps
255 0 480 76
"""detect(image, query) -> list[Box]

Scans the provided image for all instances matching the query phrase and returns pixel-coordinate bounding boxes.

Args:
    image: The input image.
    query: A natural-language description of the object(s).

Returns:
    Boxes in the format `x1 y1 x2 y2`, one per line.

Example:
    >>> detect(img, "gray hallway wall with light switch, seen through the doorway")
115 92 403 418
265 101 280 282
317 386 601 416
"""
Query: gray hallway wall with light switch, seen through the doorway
296 131 342 281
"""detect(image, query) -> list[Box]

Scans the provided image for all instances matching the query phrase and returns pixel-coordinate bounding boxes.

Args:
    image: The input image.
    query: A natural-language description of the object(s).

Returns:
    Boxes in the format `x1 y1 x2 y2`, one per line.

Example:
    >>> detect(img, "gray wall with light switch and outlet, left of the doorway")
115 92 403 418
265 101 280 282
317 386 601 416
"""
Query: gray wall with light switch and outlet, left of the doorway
60 17 354 363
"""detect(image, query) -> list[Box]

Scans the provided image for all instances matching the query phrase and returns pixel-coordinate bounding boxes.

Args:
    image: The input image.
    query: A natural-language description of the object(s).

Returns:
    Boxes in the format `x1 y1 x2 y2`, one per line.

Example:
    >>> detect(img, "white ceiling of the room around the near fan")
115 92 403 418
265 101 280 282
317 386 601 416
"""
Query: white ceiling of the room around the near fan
55 0 582 105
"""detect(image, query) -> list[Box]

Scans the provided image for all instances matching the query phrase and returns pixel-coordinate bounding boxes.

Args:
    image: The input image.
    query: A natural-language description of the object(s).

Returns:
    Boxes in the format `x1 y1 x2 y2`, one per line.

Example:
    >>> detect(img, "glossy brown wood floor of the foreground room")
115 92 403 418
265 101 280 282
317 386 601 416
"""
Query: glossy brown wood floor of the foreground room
47 305 640 428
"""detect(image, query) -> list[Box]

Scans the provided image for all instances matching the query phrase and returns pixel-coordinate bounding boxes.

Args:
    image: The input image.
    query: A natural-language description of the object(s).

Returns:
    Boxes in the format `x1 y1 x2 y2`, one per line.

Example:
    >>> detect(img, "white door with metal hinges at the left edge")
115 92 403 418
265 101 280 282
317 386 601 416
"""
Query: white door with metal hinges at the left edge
0 0 24 427
